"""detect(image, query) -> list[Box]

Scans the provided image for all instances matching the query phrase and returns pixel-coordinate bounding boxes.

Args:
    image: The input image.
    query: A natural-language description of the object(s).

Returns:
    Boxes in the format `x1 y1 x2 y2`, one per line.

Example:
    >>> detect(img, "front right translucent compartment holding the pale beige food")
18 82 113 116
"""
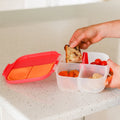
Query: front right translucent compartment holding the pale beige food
77 64 109 93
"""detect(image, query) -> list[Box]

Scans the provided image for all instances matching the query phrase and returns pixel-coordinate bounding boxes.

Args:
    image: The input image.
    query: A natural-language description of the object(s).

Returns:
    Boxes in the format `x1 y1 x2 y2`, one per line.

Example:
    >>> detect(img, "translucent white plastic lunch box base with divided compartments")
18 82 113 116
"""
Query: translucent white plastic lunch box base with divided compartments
55 52 109 93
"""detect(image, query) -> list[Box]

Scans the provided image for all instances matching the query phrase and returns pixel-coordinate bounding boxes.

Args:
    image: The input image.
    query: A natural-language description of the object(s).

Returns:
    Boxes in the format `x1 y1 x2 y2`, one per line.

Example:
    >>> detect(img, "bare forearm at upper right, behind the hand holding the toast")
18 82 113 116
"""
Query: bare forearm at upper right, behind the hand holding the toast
96 20 120 38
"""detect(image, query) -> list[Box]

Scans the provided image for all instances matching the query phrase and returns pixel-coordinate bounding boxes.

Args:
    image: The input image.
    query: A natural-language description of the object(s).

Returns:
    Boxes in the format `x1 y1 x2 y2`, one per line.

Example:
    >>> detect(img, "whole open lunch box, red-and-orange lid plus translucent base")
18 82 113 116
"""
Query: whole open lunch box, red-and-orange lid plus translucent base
3 51 109 93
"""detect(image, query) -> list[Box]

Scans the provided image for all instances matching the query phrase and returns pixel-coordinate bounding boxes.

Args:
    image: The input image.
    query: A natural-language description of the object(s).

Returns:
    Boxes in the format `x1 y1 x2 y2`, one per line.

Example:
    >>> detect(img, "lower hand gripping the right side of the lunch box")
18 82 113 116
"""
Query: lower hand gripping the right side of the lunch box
106 59 120 88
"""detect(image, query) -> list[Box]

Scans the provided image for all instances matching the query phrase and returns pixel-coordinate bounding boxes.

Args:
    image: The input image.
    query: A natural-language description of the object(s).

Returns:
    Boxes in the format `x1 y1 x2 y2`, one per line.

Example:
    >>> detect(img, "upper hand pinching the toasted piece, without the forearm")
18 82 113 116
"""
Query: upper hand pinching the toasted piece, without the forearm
69 25 104 49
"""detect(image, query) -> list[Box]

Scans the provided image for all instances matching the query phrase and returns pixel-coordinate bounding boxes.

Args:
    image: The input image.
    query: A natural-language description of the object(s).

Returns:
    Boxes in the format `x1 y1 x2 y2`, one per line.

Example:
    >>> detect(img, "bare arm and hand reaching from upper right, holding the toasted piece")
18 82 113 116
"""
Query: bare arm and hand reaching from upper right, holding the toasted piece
69 20 120 49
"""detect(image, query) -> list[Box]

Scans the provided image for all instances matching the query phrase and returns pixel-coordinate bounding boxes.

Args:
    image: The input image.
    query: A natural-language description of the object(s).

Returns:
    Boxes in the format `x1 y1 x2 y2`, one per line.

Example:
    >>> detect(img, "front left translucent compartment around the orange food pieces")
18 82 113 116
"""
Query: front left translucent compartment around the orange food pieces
56 63 80 91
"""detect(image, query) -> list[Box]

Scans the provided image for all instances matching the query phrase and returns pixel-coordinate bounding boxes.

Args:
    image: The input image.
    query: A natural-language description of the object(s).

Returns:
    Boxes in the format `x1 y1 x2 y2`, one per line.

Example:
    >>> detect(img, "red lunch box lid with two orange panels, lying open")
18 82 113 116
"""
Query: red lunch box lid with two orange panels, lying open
2 51 60 84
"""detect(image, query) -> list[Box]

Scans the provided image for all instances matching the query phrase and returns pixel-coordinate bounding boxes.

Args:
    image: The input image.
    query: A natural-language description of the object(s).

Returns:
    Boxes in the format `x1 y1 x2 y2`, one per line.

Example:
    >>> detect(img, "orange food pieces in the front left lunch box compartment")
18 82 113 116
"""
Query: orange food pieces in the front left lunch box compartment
59 70 79 77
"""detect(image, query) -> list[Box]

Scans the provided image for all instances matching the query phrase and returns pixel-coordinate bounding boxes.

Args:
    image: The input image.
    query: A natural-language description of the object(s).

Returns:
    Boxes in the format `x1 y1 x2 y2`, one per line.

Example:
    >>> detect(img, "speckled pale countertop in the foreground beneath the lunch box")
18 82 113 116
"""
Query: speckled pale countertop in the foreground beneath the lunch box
0 64 120 120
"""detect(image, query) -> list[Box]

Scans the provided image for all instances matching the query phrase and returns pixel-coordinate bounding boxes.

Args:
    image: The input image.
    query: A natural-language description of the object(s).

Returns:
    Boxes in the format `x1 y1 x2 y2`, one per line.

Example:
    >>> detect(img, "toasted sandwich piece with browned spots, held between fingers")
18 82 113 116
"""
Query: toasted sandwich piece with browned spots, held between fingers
64 45 82 63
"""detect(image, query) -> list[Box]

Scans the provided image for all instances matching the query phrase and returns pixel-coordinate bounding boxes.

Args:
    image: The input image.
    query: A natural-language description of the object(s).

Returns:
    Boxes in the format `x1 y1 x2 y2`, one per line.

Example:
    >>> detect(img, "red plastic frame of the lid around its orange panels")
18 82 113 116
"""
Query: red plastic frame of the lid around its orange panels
3 51 60 84
